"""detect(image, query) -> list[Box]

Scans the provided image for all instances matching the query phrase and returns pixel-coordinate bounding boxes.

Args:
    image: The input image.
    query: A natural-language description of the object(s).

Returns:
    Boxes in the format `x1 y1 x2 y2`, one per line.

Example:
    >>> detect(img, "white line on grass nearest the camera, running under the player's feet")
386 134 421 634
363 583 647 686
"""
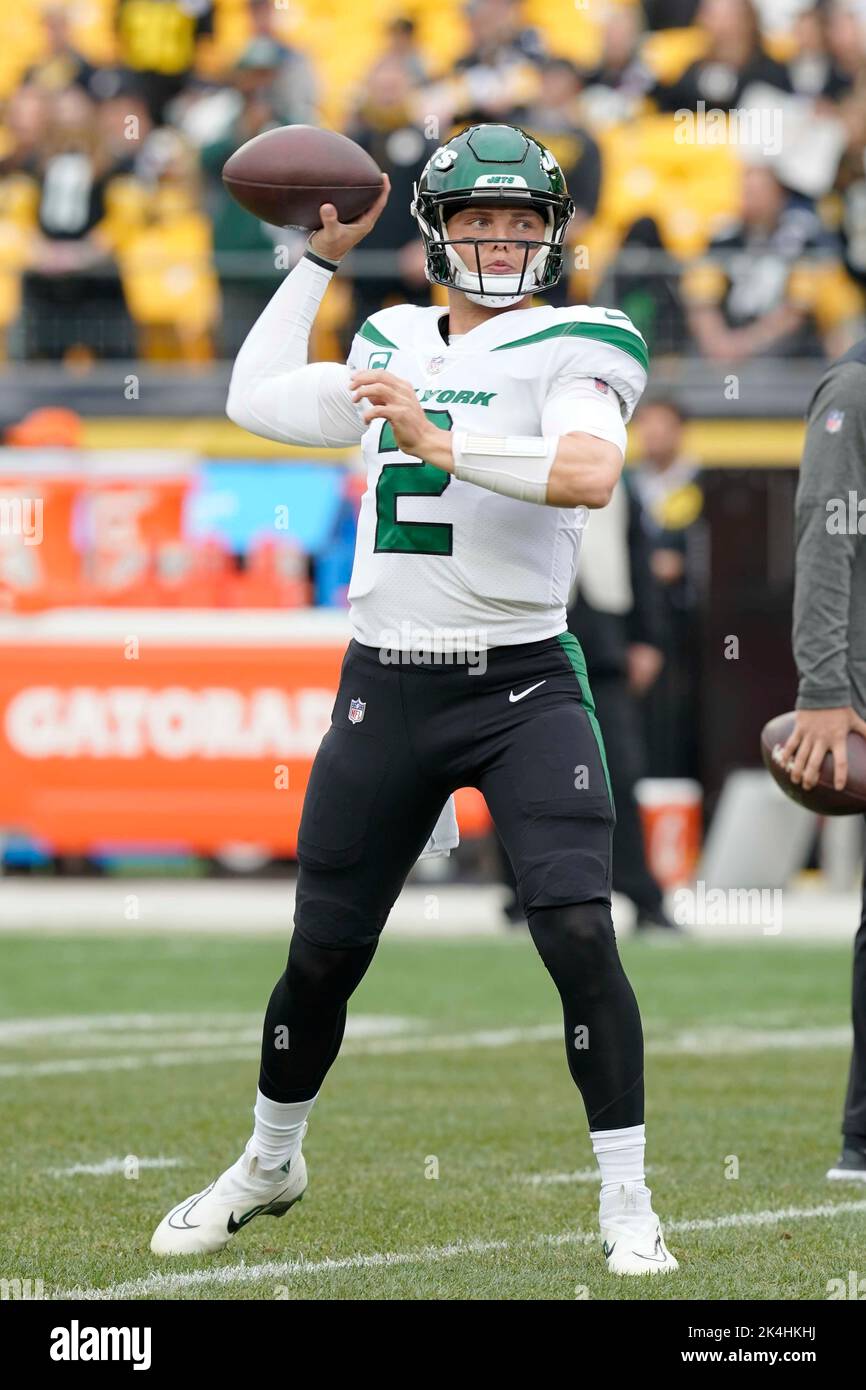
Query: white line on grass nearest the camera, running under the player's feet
57 1201 866 1300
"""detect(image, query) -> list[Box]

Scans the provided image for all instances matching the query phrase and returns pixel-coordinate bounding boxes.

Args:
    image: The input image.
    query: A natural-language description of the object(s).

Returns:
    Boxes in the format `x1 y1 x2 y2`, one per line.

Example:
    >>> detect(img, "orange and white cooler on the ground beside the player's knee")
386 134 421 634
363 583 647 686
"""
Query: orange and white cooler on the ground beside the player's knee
635 777 703 888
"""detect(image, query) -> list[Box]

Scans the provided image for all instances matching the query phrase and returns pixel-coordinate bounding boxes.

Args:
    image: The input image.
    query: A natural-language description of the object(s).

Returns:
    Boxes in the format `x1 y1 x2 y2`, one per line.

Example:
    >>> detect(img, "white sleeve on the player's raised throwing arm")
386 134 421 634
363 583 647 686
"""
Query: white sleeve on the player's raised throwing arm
225 256 367 449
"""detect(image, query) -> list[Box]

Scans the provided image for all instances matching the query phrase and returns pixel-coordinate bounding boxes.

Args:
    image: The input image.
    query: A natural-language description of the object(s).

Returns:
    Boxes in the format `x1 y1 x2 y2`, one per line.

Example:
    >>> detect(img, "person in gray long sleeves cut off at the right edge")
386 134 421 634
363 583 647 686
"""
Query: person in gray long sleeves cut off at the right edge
783 338 866 1182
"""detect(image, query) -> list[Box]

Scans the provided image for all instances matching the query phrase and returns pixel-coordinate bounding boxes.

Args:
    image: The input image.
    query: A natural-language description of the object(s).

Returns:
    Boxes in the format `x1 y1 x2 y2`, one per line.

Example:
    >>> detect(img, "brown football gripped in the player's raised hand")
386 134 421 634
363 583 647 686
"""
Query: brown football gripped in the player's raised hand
222 125 382 231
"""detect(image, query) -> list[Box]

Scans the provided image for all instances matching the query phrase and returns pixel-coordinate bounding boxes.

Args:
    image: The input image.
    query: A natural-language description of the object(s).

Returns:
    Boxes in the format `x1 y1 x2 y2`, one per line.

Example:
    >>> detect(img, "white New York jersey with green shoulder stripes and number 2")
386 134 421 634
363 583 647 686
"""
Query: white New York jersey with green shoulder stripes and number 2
341 304 648 651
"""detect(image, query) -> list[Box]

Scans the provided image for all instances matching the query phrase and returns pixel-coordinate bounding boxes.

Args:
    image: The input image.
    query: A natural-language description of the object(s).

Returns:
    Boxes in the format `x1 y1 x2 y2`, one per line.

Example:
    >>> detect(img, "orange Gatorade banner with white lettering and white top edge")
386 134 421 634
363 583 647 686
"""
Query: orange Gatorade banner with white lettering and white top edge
0 610 489 858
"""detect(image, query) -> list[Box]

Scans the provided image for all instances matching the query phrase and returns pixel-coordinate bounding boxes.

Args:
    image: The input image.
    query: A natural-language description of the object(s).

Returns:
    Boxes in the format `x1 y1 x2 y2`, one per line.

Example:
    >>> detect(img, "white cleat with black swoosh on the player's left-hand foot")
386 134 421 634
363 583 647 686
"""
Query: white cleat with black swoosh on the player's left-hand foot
150 1150 307 1255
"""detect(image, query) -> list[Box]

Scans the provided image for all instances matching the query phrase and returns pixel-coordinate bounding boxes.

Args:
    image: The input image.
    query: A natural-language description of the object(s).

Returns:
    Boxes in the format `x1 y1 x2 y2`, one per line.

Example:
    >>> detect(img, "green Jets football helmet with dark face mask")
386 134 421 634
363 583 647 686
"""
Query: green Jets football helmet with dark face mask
411 125 574 309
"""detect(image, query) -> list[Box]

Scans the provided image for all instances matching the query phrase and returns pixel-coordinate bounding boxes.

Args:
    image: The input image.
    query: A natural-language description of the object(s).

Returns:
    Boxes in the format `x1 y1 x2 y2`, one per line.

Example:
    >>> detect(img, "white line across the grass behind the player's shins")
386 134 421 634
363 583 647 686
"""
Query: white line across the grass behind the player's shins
0 1020 851 1080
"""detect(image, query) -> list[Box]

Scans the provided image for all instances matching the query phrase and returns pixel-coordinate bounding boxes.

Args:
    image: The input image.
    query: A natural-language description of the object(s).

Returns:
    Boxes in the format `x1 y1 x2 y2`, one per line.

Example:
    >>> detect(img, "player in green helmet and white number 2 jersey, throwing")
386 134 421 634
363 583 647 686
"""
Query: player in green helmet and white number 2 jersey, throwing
152 124 677 1275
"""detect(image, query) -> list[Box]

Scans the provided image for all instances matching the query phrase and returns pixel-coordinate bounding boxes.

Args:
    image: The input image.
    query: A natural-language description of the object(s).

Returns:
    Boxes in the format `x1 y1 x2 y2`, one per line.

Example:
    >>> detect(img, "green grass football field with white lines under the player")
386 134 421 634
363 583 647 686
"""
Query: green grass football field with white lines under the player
0 934 866 1300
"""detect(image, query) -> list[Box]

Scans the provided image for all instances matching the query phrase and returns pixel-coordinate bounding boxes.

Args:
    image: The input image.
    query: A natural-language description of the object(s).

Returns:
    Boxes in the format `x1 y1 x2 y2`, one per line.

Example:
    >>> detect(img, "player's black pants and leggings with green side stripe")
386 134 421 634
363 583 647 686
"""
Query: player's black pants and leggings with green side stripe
259 632 644 1129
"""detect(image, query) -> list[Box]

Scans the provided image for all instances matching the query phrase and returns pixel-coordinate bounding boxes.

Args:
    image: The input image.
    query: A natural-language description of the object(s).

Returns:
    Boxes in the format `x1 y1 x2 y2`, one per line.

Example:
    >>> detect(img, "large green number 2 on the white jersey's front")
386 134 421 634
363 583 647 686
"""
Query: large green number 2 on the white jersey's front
375 410 453 555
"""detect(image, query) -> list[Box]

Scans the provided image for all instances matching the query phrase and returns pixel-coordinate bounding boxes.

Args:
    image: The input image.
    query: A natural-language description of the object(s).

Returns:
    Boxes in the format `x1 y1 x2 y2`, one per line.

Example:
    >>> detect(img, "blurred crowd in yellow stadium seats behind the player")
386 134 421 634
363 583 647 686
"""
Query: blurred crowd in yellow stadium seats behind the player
0 0 866 363
